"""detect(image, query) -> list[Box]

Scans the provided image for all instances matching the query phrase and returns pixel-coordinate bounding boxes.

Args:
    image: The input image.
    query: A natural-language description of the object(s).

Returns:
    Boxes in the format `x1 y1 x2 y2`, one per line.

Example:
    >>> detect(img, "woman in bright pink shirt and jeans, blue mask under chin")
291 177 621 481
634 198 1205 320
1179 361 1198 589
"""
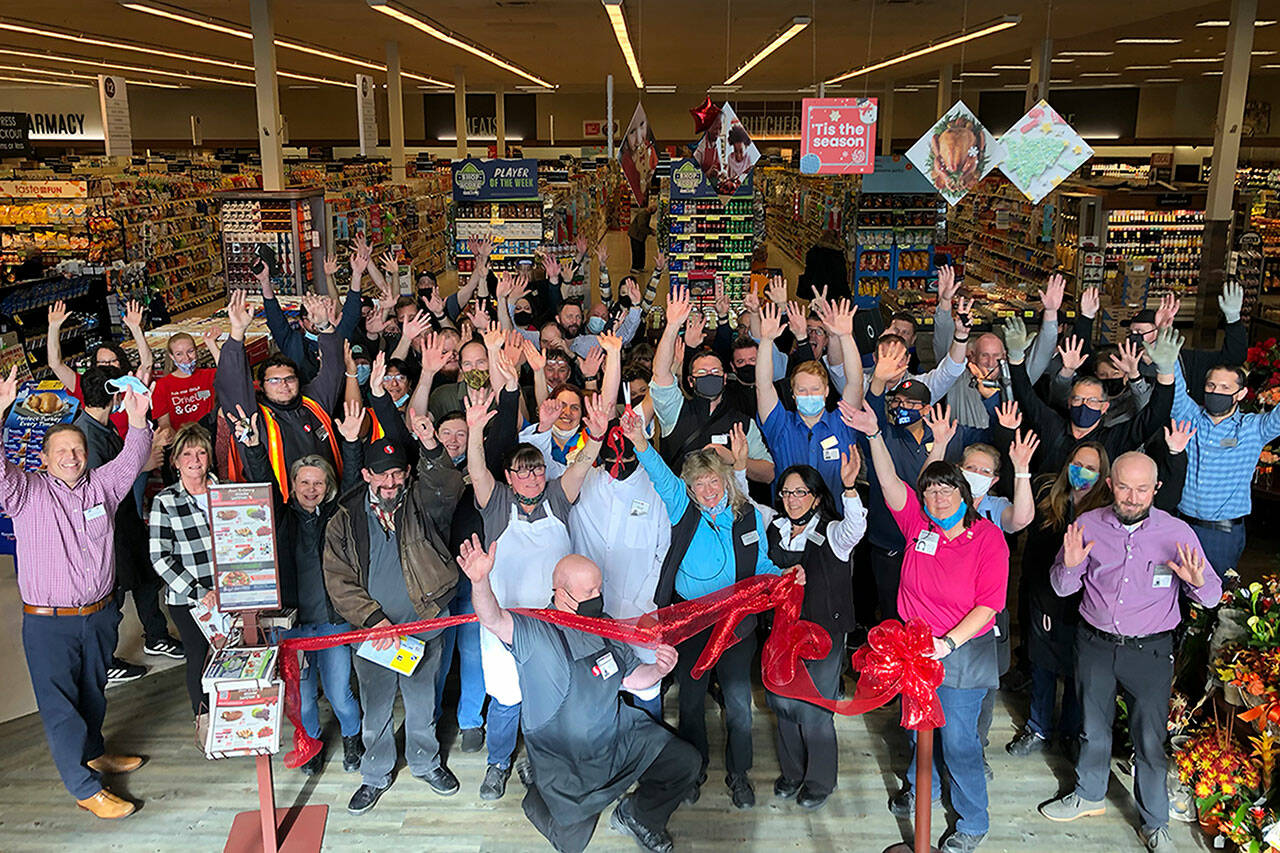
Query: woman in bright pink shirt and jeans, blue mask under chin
845 403 1009 853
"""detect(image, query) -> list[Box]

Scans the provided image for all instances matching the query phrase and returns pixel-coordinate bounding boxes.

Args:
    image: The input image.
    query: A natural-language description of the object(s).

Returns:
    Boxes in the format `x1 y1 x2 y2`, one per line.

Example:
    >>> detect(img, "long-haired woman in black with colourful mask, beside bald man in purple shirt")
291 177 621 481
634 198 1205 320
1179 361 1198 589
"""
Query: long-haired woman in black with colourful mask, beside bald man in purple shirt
1005 442 1112 760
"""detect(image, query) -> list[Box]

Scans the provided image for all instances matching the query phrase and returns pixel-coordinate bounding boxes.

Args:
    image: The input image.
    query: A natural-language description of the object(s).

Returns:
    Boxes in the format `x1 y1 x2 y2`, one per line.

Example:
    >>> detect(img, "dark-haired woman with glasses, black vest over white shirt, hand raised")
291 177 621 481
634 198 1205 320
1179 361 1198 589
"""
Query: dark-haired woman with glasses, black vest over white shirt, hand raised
765 455 867 808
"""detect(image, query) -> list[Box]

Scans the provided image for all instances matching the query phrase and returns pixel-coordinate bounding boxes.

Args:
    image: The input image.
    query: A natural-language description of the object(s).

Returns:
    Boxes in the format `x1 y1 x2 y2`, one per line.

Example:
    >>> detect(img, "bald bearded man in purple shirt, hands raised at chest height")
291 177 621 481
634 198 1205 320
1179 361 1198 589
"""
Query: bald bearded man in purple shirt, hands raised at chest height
1041 452 1222 852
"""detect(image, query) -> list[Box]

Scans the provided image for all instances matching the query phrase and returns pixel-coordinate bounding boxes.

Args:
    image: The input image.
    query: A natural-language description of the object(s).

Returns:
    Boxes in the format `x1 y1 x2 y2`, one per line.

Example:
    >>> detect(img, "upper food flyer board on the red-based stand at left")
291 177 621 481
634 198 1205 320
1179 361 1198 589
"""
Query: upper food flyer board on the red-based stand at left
209 483 280 612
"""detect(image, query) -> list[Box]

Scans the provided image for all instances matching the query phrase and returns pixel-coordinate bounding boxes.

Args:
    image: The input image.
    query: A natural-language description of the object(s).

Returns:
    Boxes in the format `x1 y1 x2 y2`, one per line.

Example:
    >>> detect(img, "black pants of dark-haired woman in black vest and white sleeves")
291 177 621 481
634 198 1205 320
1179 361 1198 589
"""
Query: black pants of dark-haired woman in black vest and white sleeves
765 634 846 797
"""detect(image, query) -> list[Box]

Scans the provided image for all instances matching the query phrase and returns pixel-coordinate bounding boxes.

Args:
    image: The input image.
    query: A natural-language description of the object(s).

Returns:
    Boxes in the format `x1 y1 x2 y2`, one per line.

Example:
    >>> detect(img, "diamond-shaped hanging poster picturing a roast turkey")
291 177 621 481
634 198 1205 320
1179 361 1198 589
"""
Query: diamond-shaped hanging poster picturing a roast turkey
906 101 1005 205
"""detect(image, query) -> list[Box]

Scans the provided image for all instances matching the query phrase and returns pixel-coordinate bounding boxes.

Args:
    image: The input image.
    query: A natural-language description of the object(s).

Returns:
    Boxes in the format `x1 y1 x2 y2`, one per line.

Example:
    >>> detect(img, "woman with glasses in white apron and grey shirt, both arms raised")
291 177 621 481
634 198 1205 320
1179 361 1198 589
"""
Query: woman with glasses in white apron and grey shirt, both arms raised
466 392 613 799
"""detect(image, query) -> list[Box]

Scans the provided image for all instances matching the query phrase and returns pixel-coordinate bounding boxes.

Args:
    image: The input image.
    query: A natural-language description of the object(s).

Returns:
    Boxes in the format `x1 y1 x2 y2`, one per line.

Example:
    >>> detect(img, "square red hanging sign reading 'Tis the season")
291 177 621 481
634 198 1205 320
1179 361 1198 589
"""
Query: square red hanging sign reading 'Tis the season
800 97 876 174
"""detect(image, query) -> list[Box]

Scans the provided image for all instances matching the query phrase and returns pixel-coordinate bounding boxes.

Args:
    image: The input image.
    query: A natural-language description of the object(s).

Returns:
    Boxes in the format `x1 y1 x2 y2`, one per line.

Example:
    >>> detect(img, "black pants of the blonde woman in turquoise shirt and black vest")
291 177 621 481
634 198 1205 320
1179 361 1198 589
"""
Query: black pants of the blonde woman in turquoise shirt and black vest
676 629 755 776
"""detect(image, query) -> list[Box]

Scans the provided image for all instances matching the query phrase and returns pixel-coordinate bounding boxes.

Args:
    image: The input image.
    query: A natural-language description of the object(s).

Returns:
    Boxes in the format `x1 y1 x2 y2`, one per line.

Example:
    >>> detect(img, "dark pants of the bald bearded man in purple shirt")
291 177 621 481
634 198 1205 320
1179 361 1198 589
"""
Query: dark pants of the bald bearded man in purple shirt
1075 622 1174 830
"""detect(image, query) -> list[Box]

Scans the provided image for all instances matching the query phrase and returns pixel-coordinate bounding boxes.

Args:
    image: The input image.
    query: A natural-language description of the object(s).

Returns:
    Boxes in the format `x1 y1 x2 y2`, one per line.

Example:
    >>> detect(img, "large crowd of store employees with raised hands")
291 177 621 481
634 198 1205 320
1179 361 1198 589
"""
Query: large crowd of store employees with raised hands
0 233 1280 853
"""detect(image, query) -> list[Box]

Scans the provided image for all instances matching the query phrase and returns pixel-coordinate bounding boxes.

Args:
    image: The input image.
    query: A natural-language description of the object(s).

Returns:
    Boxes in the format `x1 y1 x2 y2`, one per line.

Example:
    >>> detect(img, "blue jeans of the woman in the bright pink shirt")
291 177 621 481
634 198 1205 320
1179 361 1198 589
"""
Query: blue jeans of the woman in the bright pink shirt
906 686 991 835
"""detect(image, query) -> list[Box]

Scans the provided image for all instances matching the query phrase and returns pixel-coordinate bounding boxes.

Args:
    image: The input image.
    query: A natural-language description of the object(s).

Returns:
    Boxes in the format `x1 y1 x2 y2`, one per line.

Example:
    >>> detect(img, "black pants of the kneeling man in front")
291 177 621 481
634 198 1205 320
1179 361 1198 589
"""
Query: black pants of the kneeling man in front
521 738 701 853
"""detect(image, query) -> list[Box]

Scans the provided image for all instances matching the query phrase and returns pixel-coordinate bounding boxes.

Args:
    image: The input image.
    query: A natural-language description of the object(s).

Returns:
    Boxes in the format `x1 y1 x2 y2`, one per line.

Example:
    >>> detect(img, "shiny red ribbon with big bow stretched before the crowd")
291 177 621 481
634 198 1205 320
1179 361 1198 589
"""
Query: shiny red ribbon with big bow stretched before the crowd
279 575 946 767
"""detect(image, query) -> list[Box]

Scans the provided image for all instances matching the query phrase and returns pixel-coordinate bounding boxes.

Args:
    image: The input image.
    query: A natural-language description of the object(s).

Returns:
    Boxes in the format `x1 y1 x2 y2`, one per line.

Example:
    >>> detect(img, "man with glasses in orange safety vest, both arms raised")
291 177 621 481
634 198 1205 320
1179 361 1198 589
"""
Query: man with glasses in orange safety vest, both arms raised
214 291 346 501
